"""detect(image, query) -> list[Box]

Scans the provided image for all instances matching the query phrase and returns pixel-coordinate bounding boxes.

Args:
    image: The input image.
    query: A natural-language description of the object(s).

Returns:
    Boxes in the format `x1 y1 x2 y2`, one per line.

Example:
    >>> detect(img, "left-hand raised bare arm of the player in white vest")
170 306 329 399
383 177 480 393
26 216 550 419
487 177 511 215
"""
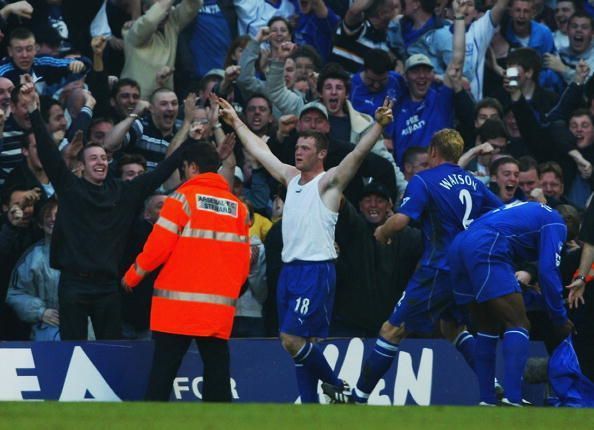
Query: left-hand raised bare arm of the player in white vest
219 98 299 185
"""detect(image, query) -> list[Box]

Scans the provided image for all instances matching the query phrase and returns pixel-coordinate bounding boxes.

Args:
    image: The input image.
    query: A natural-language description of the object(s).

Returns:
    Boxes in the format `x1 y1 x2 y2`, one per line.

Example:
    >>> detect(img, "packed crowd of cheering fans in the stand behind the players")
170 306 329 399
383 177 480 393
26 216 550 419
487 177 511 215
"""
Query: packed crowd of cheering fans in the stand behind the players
0 0 594 377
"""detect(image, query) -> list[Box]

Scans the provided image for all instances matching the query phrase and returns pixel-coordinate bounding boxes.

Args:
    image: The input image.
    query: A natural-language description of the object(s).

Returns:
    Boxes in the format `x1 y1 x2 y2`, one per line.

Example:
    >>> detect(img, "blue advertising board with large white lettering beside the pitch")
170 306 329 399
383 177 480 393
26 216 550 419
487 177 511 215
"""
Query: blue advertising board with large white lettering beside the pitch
0 338 547 405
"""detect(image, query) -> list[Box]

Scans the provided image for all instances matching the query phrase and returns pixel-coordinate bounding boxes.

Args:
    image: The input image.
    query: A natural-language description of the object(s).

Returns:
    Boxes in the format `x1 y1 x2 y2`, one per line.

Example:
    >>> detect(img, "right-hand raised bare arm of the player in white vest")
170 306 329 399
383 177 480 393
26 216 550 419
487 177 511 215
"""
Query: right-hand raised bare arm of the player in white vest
322 99 392 193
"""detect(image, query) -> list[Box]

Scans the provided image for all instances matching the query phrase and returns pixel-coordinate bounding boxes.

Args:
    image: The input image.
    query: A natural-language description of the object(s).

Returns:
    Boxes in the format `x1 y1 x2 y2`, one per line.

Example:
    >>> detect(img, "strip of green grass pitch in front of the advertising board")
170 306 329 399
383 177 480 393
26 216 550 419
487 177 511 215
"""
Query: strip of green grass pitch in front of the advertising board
0 402 594 430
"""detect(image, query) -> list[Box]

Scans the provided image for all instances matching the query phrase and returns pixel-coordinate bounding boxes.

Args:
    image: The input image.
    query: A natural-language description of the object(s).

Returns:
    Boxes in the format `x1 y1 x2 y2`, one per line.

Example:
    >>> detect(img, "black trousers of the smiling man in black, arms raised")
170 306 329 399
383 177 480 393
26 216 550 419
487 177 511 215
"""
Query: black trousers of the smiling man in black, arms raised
58 273 122 340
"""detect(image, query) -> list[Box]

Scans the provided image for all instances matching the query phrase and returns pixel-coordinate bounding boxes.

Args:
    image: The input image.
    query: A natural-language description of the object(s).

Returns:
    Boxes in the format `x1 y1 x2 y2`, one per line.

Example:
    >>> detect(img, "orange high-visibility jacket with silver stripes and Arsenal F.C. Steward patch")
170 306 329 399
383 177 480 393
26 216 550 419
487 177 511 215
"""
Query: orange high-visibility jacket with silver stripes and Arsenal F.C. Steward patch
124 173 250 339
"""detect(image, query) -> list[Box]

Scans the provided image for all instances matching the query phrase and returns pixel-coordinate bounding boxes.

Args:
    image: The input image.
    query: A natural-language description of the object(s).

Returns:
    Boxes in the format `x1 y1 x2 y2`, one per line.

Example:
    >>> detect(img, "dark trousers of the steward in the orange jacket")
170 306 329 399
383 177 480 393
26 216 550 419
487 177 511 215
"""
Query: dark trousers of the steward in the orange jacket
145 331 231 402
